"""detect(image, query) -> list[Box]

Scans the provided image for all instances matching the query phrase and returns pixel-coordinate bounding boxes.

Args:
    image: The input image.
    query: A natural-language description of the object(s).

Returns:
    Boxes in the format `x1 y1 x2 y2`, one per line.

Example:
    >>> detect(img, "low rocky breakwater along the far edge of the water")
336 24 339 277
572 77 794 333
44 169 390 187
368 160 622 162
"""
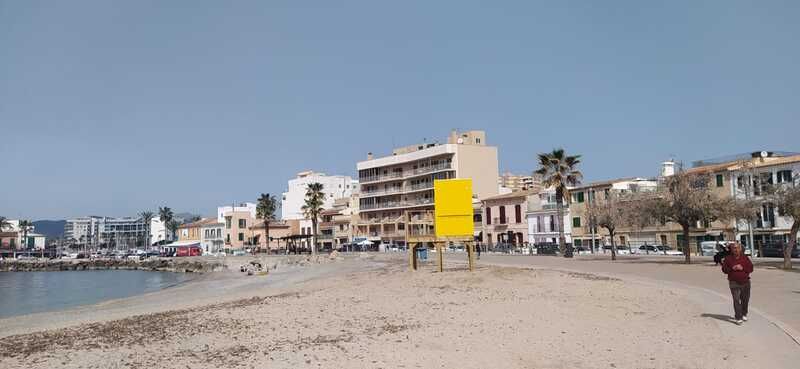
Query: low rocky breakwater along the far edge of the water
0 258 227 273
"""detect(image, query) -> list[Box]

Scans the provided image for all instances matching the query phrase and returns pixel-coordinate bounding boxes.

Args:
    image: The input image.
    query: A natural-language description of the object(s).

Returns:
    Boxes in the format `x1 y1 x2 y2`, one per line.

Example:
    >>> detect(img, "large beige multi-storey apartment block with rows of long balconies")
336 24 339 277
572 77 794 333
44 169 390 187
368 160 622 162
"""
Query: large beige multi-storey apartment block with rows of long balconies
354 131 498 245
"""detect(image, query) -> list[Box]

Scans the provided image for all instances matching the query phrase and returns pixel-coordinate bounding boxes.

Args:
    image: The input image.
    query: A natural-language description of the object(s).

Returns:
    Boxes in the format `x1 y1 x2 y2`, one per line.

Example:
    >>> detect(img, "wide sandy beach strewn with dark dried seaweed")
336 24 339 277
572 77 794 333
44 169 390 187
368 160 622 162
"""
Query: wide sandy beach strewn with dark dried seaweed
0 255 796 369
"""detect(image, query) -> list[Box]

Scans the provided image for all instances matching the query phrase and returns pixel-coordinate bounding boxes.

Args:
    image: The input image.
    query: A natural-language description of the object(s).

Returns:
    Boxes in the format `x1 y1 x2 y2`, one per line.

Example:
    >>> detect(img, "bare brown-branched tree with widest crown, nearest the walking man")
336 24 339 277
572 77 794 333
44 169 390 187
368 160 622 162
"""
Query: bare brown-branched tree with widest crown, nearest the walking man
638 172 755 264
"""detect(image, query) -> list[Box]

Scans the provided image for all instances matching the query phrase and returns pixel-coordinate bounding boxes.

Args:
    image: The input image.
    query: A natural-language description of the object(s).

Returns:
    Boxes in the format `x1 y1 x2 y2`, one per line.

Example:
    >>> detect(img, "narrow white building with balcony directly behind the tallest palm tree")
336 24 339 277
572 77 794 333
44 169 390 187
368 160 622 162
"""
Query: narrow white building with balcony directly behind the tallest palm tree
525 188 579 246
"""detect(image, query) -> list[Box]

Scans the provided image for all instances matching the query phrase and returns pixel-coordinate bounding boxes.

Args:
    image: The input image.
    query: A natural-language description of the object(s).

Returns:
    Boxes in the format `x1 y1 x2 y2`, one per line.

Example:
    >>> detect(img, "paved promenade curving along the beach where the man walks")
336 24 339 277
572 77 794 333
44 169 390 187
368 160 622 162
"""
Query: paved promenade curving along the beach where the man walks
466 254 800 349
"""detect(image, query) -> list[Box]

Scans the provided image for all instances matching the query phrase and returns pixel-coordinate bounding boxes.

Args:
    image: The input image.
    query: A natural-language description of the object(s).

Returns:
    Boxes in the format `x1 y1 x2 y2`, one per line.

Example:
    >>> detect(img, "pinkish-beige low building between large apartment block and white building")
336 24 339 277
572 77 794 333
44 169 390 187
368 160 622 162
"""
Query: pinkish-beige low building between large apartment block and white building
481 189 539 246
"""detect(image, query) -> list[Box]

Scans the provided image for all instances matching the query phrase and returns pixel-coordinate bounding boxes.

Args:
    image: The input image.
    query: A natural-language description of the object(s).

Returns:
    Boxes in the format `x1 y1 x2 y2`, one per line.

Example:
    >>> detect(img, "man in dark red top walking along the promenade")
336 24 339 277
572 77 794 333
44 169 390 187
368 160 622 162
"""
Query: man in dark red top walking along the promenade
722 242 753 325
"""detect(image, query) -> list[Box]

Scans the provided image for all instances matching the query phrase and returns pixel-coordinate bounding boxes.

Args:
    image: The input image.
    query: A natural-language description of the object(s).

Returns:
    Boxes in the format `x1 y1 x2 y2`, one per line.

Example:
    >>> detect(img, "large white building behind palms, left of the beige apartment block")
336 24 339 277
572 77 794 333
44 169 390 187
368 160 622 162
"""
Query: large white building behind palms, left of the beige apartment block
281 171 358 219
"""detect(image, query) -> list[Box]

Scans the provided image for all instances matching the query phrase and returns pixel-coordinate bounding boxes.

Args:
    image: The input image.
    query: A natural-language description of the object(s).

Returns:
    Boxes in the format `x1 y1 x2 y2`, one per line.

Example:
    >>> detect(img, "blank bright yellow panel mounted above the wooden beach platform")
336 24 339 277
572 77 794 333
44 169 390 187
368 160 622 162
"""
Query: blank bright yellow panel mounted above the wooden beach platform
433 179 475 239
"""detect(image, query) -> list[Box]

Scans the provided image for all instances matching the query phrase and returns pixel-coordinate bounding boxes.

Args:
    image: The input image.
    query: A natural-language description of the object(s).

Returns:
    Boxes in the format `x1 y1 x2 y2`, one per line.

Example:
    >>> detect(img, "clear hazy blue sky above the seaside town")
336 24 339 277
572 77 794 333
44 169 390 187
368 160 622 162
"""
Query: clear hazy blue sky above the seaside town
0 0 800 219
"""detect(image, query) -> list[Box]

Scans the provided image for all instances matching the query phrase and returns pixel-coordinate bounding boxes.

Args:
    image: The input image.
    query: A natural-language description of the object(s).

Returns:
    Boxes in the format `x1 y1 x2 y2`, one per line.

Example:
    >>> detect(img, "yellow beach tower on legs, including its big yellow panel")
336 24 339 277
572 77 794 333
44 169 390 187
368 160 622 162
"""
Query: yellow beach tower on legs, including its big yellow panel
405 179 475 272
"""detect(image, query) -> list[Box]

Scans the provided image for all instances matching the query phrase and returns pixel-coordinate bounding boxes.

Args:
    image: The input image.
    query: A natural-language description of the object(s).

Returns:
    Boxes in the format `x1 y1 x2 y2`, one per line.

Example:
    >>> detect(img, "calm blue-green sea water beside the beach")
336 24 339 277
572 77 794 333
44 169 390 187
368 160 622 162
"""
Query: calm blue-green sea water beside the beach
0 270 196 318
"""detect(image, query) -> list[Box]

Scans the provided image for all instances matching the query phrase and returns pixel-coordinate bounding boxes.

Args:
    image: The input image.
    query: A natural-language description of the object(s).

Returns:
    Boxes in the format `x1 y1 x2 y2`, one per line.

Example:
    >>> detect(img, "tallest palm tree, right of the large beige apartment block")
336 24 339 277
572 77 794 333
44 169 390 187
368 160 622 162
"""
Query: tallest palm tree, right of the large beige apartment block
535 148 583 257
